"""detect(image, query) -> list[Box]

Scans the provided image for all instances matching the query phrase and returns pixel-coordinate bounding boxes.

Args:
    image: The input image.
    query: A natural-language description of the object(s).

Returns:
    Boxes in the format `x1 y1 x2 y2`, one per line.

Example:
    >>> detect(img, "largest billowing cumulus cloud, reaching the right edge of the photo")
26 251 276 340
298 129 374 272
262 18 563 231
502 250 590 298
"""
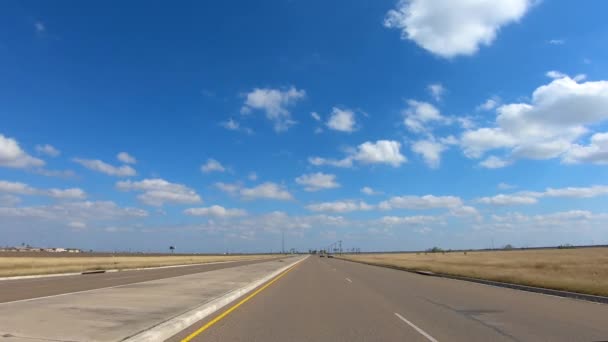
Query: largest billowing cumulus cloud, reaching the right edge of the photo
460 74 608 168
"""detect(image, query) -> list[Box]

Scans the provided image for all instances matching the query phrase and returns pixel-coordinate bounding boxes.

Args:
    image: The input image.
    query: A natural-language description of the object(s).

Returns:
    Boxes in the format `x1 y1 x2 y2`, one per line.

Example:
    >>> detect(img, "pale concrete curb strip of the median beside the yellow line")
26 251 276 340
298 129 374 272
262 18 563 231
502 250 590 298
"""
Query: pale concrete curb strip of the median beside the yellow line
123 256 308 342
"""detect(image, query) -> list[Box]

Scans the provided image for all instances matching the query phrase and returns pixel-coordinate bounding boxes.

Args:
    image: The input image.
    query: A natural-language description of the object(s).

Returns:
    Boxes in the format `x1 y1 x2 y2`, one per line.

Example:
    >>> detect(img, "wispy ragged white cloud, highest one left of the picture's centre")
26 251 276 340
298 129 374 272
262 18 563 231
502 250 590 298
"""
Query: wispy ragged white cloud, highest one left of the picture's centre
241 87 306 132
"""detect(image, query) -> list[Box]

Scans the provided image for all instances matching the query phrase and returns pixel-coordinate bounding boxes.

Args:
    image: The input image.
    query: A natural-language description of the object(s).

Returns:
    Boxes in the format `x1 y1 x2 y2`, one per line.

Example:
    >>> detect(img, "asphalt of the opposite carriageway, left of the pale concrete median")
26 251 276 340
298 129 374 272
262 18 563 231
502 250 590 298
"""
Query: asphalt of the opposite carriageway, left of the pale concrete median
0 259 276 303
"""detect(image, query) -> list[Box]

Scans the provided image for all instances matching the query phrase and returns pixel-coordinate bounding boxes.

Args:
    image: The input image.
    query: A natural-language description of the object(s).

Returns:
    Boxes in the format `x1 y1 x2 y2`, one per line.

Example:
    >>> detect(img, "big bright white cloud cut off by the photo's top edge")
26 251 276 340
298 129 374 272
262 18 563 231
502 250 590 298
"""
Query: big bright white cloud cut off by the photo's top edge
384 0 532 58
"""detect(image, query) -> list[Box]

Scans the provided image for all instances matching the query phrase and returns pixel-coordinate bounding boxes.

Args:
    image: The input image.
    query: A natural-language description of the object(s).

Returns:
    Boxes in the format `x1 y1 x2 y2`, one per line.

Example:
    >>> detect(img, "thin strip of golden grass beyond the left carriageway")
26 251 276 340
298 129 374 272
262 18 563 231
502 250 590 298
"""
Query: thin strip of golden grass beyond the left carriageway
0 255 275 277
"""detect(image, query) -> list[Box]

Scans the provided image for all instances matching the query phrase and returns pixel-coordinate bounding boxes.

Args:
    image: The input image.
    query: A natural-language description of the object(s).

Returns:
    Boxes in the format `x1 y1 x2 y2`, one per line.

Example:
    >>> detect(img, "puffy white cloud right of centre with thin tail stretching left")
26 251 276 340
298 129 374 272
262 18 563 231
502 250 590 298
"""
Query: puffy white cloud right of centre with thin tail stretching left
308 140 407 167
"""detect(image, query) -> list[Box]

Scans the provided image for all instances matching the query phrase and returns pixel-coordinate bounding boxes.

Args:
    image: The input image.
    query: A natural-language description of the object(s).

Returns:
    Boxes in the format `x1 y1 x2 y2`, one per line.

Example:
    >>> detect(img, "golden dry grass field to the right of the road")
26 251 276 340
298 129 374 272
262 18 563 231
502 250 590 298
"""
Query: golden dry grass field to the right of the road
344 248 608 296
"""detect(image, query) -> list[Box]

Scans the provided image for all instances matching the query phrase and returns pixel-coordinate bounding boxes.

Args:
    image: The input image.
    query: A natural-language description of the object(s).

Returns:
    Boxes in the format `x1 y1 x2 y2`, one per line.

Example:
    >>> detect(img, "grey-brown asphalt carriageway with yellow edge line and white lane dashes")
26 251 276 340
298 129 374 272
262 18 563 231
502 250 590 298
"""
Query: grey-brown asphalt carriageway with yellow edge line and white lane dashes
171 256 608 342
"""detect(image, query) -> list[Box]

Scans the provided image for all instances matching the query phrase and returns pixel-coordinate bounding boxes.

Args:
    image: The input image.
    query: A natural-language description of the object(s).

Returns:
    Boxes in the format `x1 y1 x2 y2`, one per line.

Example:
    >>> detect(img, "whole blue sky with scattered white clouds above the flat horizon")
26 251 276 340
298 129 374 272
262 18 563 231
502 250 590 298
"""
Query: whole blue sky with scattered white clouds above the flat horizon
0 0 608 252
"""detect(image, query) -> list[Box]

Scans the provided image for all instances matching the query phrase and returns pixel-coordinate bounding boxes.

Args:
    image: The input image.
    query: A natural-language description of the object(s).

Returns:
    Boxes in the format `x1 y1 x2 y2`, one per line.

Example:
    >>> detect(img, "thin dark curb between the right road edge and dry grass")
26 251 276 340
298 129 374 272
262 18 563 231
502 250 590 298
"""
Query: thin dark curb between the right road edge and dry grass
339 258 608 304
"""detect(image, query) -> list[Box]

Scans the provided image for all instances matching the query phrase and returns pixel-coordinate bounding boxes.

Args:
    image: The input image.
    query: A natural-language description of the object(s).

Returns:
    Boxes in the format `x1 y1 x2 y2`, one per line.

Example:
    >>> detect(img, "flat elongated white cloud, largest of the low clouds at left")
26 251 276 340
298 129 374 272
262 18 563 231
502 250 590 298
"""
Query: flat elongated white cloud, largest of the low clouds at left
116 178 202 207
